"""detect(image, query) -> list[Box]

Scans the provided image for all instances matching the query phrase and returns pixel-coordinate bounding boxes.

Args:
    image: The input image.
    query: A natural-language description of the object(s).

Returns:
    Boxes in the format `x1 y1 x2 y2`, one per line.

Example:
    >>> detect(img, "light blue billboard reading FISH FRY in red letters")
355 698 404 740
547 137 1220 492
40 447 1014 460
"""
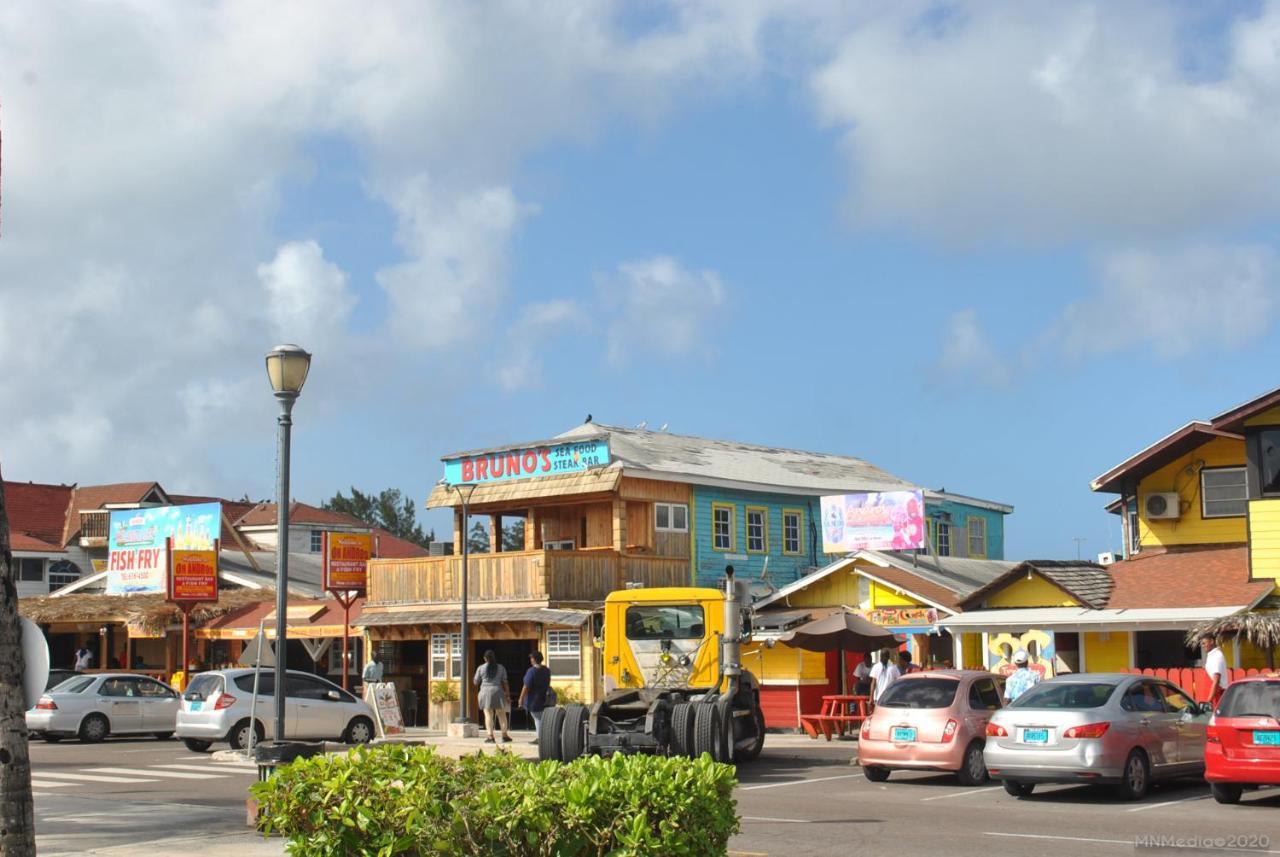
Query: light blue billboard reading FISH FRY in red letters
106 503 223 595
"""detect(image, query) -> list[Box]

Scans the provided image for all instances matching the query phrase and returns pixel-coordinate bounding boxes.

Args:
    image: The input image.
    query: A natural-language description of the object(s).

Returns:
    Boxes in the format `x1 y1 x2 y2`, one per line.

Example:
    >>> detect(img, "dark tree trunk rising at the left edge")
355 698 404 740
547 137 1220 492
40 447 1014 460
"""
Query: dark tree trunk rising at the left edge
0 470 36 857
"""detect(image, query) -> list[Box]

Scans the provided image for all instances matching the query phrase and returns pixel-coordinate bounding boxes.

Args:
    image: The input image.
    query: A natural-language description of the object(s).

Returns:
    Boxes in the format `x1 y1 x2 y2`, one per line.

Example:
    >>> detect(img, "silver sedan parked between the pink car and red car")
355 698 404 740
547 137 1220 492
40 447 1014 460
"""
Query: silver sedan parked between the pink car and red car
983 673 1211 799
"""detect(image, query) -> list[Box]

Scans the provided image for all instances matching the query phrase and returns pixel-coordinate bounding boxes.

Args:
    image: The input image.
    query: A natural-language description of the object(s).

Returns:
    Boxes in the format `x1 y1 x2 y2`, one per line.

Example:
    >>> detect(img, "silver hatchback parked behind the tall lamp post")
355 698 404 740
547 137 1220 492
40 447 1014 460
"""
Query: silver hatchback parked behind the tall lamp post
177 669 374 752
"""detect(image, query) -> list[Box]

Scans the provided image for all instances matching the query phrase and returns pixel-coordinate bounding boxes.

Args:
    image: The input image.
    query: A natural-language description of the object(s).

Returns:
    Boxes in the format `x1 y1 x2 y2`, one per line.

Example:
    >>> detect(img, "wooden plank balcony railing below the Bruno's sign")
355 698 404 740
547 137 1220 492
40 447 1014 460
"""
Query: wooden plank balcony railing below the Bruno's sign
367 550 691 605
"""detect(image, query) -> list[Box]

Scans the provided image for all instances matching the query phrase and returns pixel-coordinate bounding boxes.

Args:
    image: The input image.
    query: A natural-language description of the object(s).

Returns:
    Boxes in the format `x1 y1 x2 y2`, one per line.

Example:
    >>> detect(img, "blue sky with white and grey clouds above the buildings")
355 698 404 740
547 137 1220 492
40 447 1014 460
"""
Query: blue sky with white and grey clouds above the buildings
0 0 1280 558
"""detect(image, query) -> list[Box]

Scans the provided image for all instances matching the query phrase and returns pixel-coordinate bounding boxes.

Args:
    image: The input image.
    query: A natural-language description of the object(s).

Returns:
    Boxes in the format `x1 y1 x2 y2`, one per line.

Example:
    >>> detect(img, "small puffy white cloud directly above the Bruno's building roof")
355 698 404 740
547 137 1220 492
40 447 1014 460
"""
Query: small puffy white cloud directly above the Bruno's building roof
600 256 726 362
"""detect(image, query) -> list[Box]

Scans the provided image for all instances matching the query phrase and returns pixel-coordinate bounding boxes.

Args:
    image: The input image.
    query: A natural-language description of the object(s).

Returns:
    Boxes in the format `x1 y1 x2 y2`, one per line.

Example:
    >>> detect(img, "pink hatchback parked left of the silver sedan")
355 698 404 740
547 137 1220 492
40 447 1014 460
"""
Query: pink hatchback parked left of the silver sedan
858 669 1002 785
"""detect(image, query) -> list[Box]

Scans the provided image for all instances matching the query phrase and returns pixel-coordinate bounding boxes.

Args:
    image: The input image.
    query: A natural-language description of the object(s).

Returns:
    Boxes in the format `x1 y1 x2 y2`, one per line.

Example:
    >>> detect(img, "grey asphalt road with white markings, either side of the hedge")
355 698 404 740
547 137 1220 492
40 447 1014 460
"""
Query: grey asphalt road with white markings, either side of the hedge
32 737 1280 857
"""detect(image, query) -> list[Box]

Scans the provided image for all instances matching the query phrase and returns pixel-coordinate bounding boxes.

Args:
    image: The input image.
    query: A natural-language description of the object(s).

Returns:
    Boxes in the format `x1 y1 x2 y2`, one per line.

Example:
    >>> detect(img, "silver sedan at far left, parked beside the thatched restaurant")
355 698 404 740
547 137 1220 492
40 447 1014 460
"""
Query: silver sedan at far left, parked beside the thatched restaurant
27 673 179 743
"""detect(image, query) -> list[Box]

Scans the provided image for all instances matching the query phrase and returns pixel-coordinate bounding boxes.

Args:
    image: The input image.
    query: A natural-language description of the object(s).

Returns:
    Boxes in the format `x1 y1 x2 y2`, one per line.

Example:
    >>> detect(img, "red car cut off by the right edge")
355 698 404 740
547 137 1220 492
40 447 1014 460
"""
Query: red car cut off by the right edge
1204 674 1280 803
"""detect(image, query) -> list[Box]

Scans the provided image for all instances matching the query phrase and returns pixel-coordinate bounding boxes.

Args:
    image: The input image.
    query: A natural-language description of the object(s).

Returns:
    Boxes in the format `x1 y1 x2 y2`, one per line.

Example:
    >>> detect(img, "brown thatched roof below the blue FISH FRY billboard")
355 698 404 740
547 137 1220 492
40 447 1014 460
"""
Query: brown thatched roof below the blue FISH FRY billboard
18 588 275 631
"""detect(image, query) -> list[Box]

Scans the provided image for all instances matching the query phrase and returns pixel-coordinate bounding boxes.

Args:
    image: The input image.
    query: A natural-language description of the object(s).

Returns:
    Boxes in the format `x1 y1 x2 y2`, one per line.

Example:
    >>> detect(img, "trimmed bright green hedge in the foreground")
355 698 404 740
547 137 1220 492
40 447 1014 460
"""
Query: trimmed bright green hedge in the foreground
251 744 739 857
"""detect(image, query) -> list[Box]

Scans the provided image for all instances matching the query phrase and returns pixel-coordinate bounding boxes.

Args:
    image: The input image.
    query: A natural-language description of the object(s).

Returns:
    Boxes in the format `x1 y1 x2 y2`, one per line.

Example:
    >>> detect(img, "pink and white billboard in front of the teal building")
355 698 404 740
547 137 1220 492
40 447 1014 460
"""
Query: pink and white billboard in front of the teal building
822 491 924 554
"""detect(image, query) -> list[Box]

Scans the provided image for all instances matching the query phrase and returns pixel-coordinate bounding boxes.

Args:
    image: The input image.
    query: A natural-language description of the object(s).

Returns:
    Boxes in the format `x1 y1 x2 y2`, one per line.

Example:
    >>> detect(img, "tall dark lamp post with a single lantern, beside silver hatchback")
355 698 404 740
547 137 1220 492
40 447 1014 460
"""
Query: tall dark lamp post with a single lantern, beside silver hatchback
266 345 311 742
